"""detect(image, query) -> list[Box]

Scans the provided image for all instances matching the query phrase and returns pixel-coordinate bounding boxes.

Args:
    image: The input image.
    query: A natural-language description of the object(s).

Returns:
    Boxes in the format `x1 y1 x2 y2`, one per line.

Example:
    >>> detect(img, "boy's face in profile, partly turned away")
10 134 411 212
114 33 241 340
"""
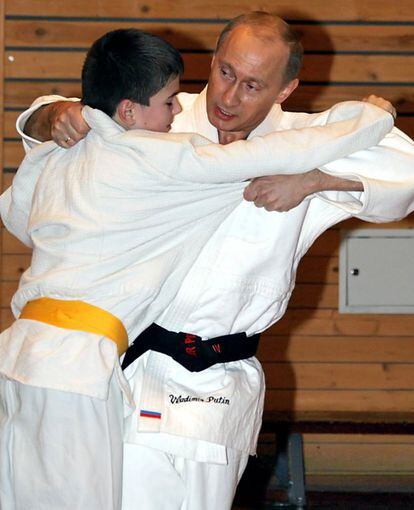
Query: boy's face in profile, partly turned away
129 76 181 133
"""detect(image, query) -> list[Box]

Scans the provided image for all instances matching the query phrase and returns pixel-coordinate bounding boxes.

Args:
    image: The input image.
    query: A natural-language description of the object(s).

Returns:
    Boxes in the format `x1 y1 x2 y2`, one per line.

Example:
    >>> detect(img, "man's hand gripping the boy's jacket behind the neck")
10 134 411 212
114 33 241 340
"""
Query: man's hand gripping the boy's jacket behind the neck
49 101 90 149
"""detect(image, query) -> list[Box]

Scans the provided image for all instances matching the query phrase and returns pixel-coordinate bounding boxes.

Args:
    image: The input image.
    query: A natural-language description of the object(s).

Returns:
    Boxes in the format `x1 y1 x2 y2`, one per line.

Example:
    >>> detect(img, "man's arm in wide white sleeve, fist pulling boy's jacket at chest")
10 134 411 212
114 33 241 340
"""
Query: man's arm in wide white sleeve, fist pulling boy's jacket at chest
245 124 414 222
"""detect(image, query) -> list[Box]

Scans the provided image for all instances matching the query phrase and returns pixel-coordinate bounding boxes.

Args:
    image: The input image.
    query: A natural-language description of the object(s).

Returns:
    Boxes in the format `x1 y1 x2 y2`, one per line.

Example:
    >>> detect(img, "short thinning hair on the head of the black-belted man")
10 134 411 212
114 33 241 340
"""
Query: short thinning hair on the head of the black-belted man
216 11 303 84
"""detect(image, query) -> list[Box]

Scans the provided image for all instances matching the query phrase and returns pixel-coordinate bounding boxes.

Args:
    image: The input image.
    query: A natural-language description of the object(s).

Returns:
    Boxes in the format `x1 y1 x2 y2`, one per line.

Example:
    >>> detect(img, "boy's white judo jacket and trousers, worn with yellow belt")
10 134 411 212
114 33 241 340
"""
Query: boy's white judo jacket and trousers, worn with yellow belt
0 103 392 510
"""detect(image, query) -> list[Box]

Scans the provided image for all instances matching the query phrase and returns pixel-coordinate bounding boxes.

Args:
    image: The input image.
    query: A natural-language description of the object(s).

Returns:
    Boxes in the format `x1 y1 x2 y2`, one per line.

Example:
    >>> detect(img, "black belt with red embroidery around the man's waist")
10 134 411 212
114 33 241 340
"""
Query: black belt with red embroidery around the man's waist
122 324 260 372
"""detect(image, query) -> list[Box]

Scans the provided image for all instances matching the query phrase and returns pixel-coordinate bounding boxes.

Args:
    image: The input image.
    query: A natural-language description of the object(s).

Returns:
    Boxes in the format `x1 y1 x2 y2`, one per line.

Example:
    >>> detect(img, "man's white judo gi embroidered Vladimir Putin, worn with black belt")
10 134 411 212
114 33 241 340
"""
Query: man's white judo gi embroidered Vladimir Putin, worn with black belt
119 91 414 510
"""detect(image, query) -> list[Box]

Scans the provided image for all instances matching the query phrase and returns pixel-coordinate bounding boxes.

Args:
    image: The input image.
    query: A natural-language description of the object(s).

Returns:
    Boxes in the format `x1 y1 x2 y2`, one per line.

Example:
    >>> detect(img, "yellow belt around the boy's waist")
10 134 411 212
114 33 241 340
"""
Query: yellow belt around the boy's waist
19 298 128 356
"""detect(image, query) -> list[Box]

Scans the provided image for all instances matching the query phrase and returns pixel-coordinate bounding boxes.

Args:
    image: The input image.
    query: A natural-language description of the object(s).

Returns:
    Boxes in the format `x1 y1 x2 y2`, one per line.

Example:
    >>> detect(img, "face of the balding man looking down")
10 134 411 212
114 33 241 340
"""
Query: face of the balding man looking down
207 26 298 136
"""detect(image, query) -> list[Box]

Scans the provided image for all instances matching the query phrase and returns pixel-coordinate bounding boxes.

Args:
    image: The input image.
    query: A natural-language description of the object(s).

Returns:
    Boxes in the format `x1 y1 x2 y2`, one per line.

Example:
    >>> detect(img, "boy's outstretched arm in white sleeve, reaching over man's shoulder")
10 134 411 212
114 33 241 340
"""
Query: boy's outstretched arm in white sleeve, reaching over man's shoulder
111 102 393 183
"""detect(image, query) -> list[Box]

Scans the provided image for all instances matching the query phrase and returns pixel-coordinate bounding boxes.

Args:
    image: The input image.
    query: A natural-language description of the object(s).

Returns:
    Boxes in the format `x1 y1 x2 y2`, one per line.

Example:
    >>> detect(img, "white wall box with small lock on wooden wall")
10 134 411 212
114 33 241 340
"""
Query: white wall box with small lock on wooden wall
339 229 414 313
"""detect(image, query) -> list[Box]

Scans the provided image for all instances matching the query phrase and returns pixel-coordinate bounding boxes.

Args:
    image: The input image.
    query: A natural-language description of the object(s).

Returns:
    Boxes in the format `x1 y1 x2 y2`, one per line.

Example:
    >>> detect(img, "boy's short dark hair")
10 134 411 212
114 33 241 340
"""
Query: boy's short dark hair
82 28 184 117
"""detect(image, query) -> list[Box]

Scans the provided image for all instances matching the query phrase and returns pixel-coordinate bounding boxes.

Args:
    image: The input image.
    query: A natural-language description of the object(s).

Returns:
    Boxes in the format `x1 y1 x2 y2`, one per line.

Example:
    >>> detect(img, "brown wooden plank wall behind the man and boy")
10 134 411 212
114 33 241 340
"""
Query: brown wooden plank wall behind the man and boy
0 0 414 494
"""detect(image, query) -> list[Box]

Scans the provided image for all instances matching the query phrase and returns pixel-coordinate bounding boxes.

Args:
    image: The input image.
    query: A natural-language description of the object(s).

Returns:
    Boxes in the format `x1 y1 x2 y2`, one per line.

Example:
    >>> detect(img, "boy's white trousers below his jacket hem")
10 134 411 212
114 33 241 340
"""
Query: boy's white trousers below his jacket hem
0 378 123 510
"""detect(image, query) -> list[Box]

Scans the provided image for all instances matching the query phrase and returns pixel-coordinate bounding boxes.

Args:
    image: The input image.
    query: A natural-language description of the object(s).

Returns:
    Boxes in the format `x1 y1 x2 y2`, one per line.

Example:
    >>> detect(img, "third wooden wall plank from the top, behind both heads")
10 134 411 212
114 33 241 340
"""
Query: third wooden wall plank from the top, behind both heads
5 50 414 83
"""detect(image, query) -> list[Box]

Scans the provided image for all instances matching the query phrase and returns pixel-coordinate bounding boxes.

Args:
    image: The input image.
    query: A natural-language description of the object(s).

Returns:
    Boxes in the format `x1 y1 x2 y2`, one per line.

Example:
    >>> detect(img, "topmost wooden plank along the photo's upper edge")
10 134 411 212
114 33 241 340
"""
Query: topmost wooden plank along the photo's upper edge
6 0 413 21
